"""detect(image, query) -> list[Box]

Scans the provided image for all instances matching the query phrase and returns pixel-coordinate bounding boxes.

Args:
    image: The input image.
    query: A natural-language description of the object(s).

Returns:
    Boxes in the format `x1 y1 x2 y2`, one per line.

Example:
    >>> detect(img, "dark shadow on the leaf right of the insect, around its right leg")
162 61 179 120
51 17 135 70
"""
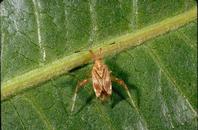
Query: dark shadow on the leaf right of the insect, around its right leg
105 56 141 108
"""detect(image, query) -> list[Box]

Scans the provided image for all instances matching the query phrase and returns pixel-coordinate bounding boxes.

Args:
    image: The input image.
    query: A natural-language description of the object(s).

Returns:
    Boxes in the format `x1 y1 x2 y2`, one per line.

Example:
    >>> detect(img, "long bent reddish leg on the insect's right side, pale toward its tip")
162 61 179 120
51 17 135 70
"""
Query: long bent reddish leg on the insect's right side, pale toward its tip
111 76 137 109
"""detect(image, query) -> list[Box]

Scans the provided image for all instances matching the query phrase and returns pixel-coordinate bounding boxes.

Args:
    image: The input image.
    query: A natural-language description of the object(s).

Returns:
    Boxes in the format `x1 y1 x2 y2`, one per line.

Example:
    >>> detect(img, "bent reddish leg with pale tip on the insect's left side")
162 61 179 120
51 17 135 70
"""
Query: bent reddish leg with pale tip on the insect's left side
71 79 89 112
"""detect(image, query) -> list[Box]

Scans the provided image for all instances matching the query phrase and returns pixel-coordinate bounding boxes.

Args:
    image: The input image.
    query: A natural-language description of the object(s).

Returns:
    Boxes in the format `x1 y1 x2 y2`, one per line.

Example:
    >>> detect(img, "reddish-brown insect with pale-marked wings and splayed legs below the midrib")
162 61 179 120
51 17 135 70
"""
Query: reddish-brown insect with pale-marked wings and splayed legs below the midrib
71 48 134 111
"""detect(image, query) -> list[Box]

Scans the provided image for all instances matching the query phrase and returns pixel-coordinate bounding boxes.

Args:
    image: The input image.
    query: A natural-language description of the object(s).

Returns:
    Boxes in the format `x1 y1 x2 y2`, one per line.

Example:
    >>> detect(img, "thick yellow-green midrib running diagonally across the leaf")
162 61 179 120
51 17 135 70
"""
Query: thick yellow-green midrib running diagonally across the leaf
1 6 197 100
